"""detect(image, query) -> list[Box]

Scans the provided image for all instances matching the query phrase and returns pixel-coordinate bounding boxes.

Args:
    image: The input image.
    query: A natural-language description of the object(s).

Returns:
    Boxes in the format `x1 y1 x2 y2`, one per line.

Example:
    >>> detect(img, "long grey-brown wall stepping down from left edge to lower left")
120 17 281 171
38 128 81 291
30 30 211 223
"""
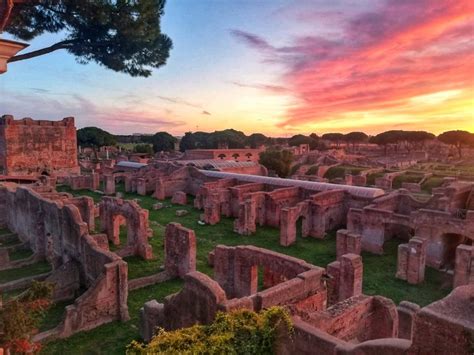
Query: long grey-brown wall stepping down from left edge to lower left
0 184 128 337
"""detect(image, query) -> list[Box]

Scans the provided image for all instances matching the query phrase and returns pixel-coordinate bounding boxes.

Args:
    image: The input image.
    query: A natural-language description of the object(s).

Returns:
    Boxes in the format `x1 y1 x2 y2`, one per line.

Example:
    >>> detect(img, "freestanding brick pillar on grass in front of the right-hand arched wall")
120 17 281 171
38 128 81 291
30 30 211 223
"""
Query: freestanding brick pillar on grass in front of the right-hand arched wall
395 237 427 285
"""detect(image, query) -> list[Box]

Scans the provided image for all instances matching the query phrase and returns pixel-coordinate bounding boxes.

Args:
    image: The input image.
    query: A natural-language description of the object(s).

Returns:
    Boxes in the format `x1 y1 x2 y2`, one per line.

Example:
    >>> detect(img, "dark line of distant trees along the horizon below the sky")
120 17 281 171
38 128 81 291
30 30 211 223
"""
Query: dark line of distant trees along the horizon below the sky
77 127 474 155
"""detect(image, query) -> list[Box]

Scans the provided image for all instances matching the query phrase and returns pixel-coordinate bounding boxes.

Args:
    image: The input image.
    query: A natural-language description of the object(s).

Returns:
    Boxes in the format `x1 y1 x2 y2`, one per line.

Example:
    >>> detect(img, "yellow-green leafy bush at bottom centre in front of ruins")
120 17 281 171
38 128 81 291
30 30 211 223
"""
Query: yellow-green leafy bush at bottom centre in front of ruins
127 307 293 354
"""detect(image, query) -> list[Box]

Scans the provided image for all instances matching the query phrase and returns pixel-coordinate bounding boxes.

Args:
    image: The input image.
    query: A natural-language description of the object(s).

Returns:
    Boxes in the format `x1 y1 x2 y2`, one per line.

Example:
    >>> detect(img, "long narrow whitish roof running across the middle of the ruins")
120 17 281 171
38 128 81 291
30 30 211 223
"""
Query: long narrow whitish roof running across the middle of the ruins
200 170 385 198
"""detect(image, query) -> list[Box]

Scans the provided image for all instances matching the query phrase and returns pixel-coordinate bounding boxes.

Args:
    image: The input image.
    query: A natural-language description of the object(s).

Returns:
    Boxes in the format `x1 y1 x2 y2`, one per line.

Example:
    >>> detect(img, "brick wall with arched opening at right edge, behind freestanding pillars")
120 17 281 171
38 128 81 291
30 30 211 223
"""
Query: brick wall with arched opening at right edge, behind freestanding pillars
347 183 474 276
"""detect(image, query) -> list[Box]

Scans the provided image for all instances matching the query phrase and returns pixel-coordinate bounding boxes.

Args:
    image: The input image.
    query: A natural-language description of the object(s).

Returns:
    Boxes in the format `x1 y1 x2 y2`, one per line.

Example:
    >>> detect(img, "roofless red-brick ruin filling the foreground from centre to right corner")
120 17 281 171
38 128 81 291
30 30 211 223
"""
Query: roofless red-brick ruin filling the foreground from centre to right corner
140 244 474 355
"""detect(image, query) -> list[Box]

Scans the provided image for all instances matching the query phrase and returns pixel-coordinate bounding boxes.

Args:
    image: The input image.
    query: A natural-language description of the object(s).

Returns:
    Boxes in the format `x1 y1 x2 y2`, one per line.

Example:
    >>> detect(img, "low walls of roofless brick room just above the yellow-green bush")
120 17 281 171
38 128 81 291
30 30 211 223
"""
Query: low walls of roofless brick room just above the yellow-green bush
140 246 326 339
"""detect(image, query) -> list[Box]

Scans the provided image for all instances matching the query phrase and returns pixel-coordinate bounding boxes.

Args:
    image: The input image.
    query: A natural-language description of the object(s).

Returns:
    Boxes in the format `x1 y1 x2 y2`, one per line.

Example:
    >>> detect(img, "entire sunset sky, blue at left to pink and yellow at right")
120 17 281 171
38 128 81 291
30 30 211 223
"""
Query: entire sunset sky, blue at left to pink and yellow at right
0 0 474 136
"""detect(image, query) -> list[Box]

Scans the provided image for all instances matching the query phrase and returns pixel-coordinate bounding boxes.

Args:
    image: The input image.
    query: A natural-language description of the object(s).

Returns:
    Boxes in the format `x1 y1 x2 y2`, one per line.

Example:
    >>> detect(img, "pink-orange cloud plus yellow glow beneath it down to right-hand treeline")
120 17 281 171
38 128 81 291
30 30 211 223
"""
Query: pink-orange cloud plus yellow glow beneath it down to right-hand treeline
232 0 474 132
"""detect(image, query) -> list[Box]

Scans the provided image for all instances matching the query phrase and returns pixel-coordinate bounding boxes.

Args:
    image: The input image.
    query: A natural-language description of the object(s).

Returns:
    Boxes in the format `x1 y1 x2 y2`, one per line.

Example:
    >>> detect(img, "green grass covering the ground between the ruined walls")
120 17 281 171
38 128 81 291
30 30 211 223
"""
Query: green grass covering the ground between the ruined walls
6 188 449 354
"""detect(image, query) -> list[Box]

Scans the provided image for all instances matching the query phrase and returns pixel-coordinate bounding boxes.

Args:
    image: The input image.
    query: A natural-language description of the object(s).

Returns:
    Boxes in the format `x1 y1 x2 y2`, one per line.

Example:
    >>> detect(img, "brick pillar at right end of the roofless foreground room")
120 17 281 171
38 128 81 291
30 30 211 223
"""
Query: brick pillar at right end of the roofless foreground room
339 254 363 301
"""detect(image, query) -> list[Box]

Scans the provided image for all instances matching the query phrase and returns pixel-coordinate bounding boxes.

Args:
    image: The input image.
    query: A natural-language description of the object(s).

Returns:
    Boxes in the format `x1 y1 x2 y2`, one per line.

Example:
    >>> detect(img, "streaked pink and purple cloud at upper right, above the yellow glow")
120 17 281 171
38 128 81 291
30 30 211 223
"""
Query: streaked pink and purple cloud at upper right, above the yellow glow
231 0 474 128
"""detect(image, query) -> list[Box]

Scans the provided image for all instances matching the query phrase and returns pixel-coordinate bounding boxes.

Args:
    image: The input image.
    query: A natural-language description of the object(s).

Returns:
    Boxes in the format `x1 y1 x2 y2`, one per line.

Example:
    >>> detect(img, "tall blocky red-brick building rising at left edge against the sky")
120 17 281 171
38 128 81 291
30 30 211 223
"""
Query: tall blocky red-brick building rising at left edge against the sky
0 115 79 176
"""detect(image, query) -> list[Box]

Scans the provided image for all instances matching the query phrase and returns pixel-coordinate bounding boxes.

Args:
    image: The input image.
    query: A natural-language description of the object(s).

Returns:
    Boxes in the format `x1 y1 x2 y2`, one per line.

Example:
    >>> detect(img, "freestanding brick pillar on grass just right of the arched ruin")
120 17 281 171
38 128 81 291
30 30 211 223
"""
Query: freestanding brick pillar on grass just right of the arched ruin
165 223 196 278
